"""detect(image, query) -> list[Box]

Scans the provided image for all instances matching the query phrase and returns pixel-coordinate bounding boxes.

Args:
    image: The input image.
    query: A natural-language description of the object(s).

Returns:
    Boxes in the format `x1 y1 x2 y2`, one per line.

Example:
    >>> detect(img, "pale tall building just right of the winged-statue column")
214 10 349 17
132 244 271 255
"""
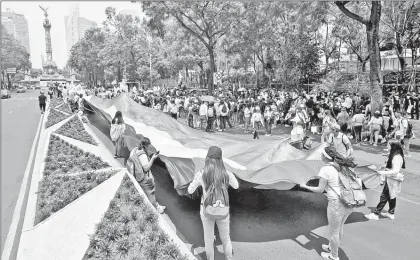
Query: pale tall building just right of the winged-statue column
64 4 98 56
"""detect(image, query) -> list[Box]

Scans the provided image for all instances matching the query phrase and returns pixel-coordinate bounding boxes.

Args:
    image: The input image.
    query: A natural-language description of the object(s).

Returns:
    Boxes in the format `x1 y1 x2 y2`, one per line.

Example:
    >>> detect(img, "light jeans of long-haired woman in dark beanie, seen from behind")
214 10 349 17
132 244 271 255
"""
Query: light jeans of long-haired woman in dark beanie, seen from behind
200 209 233 260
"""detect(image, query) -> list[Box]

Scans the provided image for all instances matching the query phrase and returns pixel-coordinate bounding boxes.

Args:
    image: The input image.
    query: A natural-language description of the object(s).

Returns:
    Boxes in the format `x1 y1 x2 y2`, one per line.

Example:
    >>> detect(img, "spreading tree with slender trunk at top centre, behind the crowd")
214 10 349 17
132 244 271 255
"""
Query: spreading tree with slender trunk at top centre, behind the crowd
142 1 244 92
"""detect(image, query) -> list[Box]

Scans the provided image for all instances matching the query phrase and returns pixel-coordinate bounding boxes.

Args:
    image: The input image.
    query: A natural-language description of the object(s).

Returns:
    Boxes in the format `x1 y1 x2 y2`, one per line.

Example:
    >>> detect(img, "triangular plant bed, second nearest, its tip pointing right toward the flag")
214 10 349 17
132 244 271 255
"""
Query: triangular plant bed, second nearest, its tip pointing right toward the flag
35 170 117 225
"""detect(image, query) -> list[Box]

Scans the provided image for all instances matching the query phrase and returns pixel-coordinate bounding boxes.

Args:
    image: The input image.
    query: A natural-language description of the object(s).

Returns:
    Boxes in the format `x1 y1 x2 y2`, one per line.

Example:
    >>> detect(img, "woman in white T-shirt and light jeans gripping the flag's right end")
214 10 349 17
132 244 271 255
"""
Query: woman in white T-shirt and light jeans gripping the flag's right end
300 147 356 260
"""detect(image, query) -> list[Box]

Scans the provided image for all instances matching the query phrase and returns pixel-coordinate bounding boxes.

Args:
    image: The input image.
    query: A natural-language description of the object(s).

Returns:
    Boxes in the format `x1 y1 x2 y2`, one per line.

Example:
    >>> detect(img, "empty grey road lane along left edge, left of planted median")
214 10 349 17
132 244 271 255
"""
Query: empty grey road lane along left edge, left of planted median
0 90 41 252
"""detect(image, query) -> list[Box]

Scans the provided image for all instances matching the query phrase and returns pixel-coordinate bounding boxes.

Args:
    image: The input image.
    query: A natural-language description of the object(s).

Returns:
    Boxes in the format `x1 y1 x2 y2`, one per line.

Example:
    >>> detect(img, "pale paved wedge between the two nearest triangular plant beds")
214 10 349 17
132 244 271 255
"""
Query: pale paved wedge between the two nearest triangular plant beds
17 170 126 260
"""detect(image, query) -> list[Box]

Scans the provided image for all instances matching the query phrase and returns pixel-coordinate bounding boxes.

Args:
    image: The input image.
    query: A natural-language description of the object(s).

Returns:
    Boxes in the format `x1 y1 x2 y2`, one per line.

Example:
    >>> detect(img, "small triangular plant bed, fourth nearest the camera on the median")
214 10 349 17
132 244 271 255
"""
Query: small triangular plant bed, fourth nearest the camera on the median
55 116 98 145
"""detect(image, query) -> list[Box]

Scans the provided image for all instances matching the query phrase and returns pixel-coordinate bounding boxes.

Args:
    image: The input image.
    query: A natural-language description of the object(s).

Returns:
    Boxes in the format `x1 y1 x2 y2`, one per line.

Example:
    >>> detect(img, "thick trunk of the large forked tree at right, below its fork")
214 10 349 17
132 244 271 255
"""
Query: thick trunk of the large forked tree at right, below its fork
366 19 382 111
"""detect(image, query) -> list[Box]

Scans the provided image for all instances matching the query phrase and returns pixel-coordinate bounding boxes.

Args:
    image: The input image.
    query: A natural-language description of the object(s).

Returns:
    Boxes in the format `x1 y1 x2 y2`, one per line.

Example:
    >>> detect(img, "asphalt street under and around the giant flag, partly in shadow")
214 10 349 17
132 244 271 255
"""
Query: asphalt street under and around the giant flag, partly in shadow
89 110 420 260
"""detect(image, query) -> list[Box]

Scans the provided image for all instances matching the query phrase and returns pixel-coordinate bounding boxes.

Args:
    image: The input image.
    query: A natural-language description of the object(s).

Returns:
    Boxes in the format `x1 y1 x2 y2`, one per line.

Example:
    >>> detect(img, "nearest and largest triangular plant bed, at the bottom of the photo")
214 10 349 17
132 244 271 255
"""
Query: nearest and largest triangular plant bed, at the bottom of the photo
83 175 187 260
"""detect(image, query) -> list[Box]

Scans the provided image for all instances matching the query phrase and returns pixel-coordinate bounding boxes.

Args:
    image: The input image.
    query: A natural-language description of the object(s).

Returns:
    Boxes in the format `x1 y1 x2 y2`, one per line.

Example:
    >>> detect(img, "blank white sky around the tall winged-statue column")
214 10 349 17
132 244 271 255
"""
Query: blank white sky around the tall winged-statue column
1 0 141 68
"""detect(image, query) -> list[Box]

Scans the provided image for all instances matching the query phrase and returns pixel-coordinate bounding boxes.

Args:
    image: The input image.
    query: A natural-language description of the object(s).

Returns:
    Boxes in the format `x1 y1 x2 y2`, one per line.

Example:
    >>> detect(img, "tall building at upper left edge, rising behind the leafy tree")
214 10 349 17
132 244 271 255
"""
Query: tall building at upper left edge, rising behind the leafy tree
1 9 31 53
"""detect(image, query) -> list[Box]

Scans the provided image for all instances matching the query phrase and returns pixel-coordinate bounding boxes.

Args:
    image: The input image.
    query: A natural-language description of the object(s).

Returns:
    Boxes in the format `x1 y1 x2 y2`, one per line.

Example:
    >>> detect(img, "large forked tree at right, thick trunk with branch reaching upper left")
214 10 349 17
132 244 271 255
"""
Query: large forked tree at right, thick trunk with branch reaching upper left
335 1 382 110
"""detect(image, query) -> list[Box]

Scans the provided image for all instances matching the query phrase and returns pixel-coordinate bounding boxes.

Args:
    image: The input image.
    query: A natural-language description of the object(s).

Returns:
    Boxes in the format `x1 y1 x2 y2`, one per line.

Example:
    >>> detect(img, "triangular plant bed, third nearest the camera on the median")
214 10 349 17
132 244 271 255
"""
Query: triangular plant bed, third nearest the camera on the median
44 135 110 176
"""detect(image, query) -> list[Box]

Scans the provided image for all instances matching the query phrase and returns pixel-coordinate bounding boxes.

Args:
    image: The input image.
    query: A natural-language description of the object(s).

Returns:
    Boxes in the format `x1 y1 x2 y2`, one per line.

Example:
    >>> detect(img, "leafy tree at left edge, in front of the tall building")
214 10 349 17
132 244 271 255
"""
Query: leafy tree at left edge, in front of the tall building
1 25 32 88
